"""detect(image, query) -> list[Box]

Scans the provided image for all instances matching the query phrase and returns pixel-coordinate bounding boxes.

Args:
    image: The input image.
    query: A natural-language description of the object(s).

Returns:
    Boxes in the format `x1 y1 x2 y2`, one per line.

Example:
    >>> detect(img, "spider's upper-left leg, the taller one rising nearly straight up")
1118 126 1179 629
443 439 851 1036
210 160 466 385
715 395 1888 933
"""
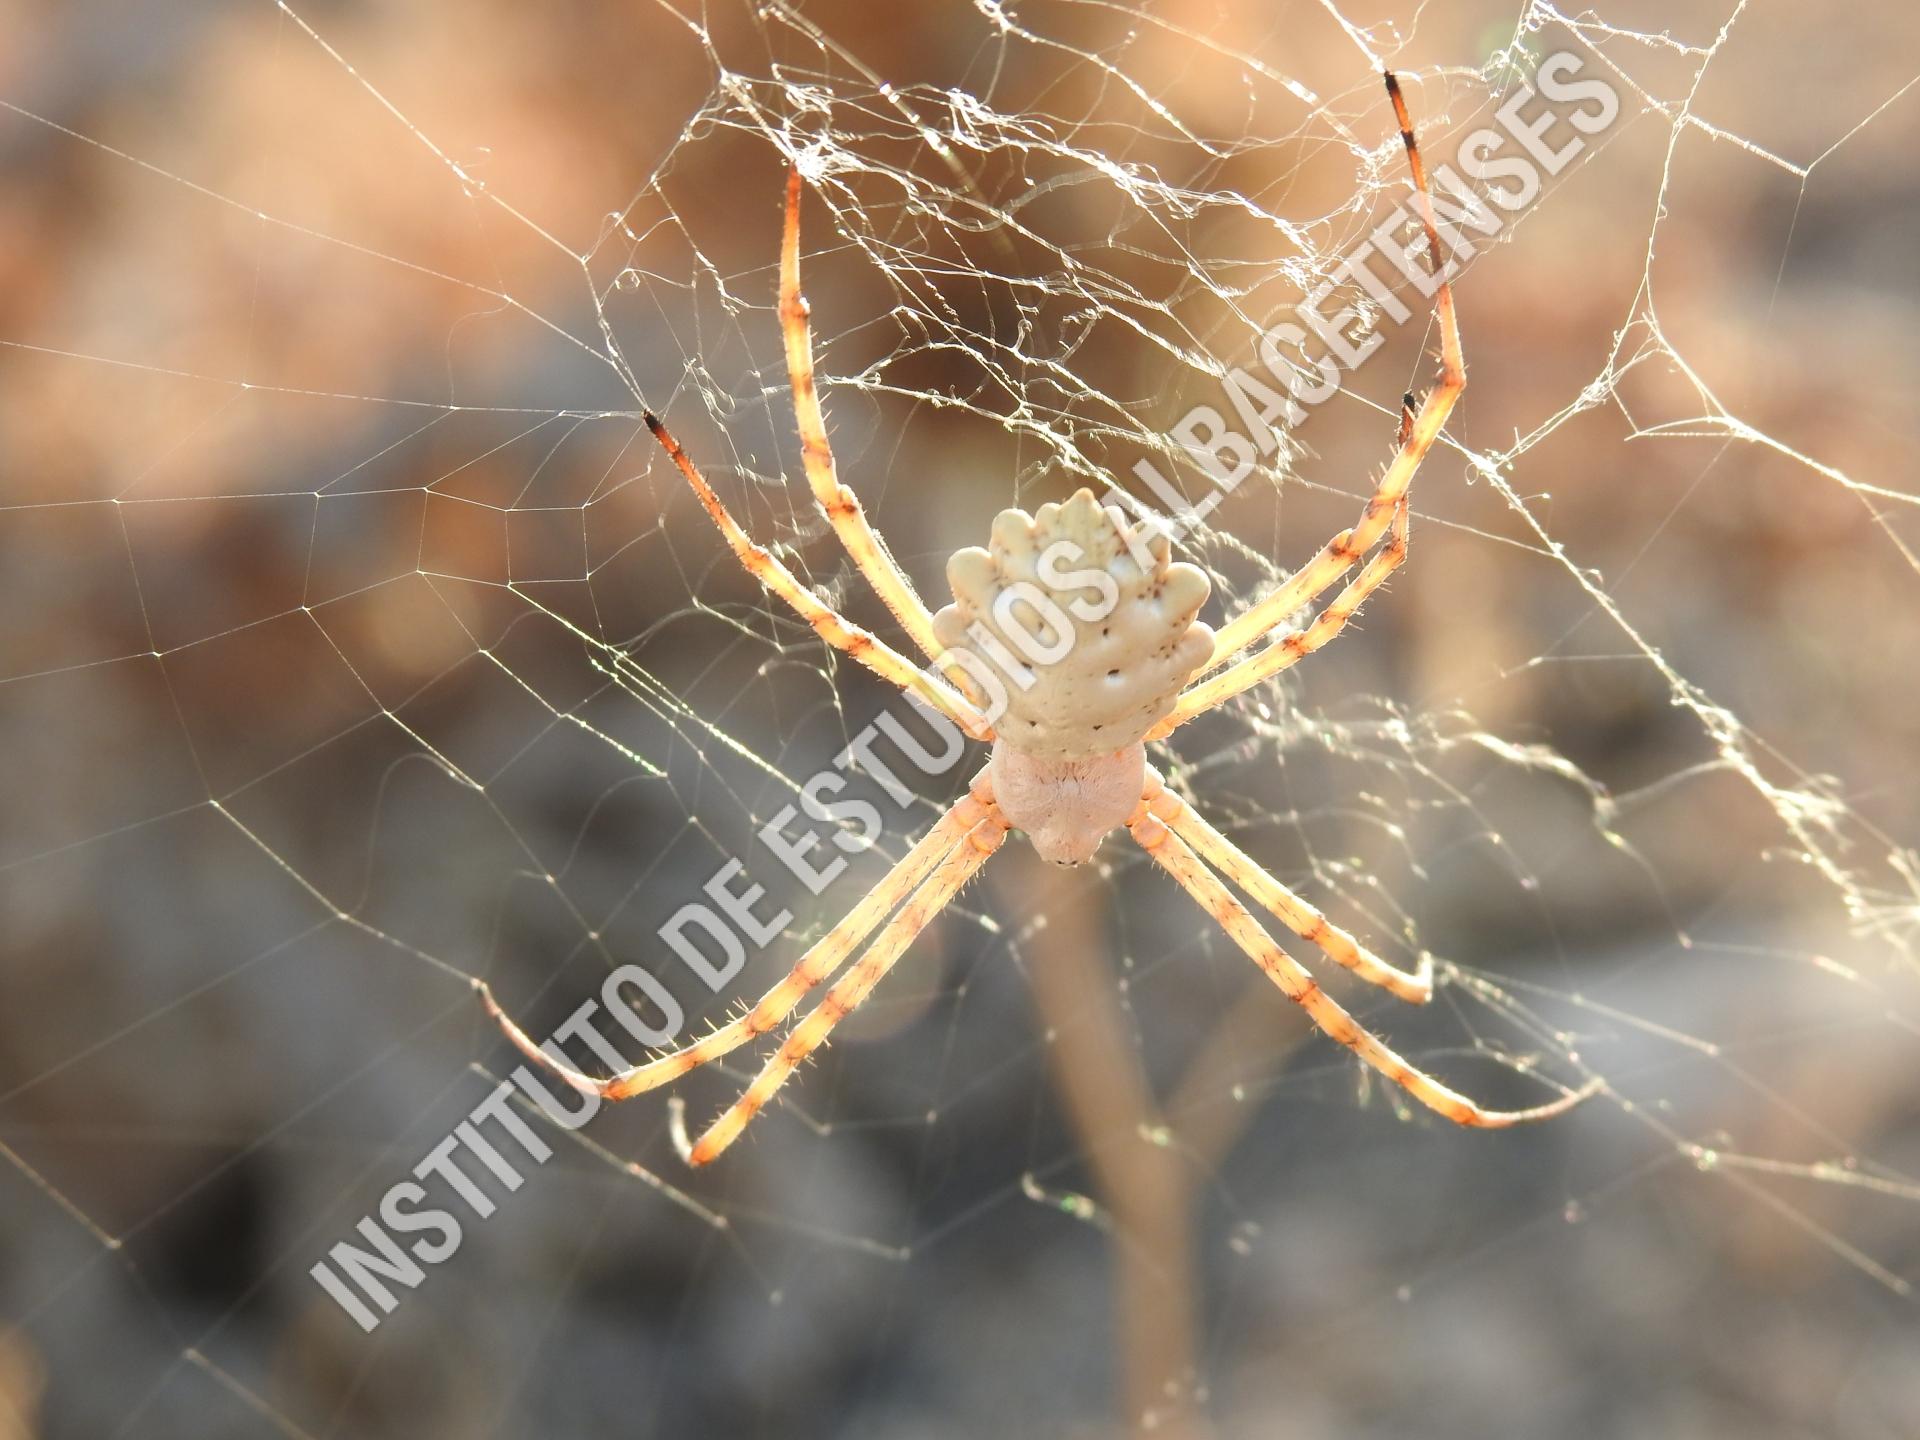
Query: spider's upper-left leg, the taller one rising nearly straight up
780 165 945 660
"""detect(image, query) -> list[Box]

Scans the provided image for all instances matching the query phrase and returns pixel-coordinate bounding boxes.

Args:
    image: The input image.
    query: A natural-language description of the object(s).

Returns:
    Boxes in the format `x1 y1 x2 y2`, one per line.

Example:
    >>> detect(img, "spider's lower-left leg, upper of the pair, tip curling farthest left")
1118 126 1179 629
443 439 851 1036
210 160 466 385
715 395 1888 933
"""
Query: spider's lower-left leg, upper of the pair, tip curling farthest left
476 772 993 1100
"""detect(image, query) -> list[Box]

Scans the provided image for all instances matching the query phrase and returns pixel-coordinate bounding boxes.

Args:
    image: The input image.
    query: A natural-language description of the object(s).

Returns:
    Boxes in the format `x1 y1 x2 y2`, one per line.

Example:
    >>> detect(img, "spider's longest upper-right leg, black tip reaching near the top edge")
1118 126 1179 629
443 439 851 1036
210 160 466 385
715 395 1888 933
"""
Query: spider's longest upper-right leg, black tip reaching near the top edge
1182 71 1467 699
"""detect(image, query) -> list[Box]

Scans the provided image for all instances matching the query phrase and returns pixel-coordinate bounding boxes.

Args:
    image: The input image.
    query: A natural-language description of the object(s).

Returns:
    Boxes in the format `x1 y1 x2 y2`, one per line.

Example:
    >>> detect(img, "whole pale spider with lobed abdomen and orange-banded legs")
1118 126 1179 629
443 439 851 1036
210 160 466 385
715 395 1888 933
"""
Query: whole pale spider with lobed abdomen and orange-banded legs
478 71 1597 1165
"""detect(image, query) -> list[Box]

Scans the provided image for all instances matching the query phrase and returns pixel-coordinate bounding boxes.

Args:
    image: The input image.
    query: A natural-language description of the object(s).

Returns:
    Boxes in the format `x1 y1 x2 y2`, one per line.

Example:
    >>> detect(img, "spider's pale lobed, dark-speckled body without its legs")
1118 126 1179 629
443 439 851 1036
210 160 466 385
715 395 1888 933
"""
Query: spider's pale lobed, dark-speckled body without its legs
933 490 1213 864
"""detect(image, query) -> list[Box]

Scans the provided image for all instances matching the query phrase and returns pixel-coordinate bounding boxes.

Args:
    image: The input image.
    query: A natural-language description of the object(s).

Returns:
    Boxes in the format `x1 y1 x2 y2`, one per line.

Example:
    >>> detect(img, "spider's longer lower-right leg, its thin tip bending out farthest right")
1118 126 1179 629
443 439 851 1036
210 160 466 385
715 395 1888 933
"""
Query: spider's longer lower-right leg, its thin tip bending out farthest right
1127 801 1601 1129
